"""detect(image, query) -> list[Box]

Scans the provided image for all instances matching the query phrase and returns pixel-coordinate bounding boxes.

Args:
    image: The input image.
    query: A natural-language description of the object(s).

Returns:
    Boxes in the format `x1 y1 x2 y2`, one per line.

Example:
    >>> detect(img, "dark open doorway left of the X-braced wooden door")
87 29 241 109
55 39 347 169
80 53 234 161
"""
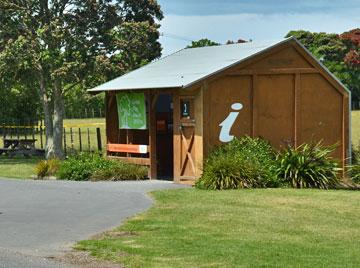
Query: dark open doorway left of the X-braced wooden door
156 94 174 180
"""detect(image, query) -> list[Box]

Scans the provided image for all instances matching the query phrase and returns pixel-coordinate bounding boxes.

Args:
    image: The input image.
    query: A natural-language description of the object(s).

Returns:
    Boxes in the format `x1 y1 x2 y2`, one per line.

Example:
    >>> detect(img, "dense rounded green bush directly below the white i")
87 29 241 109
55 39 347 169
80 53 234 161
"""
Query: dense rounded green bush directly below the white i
196 137 279 190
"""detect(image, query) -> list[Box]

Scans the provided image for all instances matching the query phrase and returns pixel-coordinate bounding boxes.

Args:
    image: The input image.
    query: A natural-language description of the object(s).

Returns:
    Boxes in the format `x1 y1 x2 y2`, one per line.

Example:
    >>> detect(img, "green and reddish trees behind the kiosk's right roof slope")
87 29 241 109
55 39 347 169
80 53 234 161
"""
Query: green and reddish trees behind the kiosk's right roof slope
287 29 360 104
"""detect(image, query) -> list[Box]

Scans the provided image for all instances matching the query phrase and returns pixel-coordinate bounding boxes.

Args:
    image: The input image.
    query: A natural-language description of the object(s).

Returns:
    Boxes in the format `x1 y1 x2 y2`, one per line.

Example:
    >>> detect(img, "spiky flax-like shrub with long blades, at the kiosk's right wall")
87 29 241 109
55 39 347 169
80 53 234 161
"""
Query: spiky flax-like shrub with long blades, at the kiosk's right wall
277 142 341 189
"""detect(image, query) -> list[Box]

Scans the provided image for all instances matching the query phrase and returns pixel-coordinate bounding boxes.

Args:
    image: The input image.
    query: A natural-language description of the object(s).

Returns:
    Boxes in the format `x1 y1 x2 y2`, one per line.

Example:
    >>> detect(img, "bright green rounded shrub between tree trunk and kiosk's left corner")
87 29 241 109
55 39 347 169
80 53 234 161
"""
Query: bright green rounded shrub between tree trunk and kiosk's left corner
57 153 114 181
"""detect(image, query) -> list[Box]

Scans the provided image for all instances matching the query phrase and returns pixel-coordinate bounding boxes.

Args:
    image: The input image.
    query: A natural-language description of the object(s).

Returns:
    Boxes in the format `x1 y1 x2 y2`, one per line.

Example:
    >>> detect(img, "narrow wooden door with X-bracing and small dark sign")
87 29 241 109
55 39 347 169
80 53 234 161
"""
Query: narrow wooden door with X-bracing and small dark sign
174 96 196 181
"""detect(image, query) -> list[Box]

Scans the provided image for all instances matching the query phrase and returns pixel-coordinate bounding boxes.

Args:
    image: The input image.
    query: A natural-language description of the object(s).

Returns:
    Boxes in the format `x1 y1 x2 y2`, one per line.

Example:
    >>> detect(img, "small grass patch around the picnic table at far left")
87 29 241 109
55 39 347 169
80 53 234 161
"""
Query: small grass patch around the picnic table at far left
0 157 40 179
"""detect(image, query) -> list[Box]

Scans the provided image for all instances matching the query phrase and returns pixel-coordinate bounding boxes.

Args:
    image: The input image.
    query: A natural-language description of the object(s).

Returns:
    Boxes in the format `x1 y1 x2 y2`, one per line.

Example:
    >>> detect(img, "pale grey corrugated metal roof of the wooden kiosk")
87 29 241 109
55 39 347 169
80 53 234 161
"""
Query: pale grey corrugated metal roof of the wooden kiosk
89 37 292 92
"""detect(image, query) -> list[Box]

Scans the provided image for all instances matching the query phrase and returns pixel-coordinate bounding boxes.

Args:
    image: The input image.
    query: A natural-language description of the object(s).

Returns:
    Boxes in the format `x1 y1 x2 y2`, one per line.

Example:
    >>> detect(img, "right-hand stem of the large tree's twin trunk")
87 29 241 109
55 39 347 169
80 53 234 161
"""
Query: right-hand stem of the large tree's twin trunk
53 81 64 159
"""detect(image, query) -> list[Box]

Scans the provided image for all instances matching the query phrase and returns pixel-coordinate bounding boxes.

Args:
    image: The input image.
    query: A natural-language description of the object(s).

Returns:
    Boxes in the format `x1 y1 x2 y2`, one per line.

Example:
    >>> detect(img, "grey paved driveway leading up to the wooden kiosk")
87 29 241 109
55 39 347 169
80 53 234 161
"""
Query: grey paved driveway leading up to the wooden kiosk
0 179 186 268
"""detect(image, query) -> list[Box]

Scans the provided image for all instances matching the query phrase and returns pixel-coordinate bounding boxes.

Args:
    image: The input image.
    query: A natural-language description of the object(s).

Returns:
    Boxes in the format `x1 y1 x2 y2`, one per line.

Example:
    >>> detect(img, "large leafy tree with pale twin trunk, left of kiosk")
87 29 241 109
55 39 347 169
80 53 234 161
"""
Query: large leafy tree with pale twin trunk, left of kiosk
0 0 163 158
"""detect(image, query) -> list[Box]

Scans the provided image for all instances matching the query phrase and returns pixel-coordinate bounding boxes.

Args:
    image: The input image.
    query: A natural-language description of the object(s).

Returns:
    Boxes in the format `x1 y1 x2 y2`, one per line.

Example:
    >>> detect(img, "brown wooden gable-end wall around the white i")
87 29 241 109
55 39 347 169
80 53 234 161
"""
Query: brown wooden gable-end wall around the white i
204 44 349 168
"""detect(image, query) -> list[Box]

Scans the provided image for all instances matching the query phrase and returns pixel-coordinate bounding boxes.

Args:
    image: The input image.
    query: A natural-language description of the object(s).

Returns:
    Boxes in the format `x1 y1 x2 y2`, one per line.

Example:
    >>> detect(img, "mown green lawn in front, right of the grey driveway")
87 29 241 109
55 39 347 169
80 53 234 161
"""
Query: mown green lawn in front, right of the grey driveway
77 189 360 267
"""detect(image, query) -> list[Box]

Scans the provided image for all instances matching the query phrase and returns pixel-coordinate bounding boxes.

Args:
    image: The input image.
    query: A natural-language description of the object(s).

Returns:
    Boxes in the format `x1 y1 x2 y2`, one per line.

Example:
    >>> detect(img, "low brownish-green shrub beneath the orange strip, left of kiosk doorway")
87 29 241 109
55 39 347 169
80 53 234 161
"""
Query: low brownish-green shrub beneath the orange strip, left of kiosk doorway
91 161 148 181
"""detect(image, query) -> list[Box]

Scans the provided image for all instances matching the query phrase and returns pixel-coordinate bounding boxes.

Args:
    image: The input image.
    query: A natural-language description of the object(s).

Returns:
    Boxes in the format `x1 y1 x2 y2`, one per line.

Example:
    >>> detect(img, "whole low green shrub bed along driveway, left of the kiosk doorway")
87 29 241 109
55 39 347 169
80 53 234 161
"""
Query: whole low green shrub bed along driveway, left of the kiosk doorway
57 153 147 181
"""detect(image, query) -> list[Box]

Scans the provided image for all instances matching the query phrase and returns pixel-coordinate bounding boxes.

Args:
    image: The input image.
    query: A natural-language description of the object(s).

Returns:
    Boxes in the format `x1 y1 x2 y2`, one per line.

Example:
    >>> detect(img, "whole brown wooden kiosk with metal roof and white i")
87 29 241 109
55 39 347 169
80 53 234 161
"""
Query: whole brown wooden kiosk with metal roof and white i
89 37 350 182
